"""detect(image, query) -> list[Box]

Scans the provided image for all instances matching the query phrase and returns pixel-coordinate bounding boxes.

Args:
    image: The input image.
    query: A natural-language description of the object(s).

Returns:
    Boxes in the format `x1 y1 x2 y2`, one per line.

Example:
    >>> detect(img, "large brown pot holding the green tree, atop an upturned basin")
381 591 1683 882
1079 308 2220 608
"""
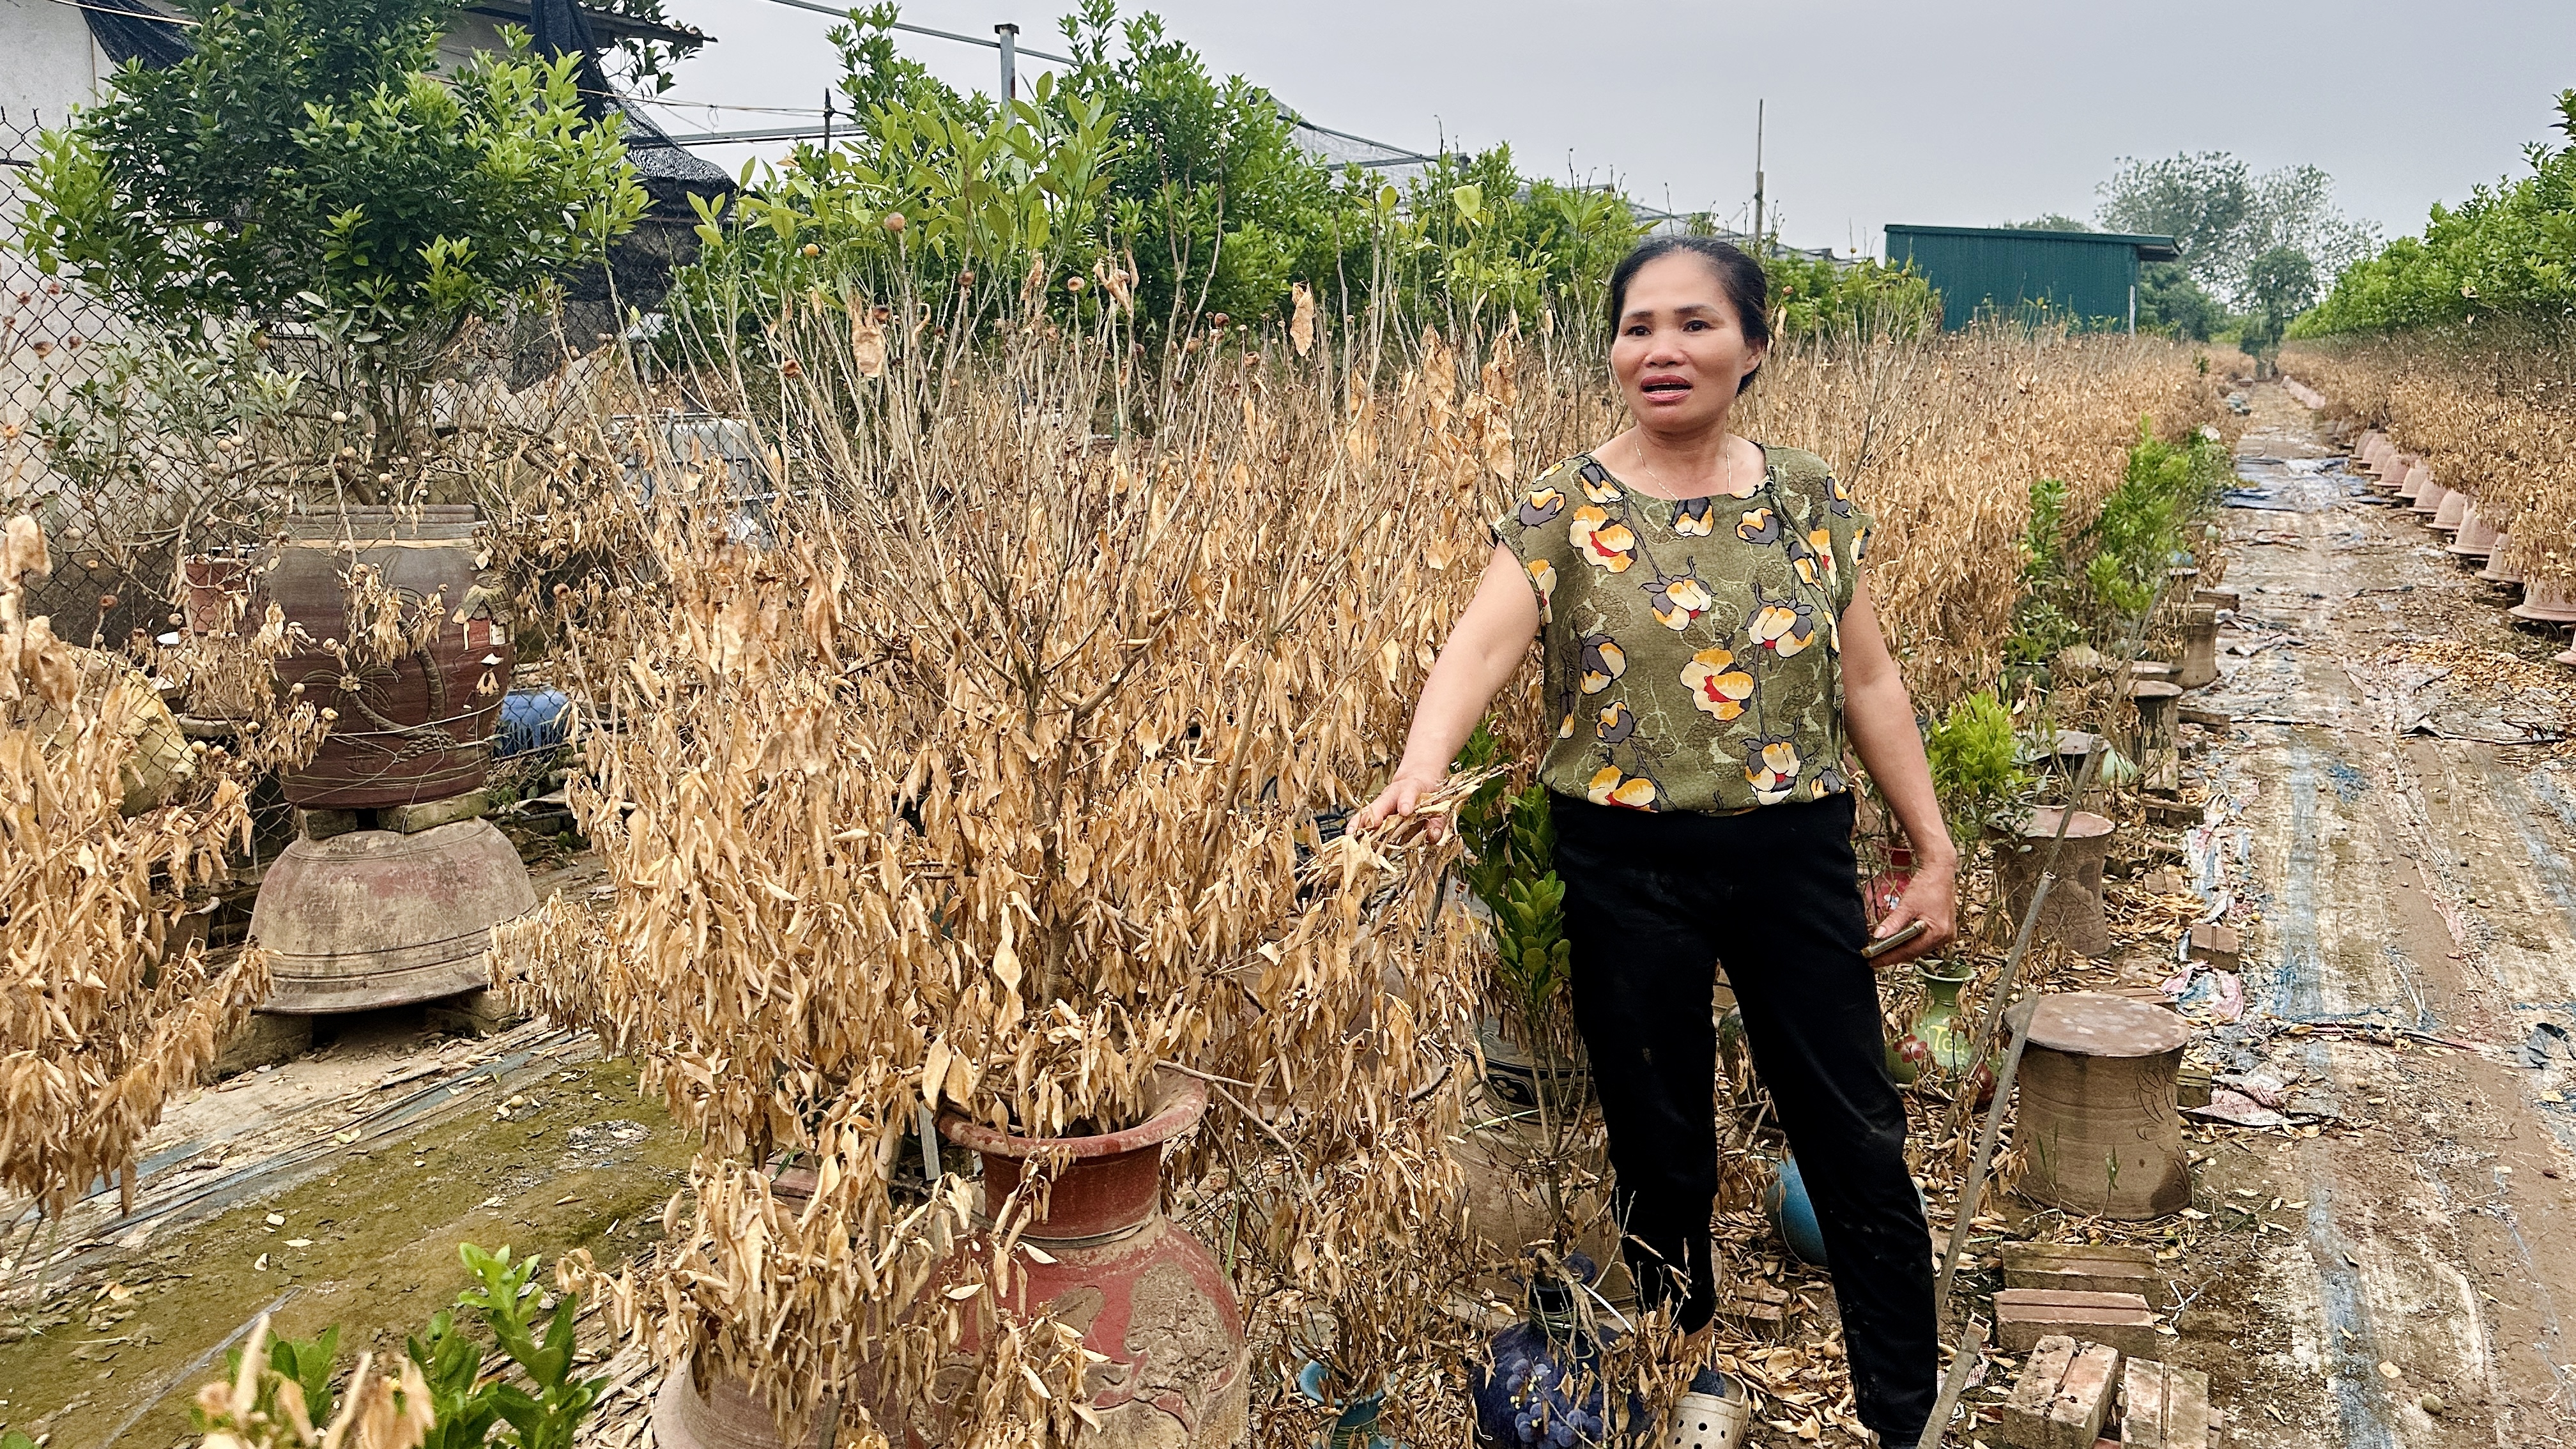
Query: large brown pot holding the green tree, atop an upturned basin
252 505 510 809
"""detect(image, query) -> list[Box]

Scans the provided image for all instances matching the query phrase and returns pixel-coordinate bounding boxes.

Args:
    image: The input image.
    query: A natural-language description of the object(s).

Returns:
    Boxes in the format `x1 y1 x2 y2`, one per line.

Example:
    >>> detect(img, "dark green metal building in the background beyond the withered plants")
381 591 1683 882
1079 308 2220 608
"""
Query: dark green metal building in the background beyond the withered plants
1888 227 2182 333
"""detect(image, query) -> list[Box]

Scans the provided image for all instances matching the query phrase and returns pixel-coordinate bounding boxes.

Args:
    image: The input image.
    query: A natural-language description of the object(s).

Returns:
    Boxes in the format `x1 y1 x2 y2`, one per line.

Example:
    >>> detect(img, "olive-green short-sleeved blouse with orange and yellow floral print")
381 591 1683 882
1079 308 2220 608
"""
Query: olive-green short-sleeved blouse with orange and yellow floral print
1494 446 1870 815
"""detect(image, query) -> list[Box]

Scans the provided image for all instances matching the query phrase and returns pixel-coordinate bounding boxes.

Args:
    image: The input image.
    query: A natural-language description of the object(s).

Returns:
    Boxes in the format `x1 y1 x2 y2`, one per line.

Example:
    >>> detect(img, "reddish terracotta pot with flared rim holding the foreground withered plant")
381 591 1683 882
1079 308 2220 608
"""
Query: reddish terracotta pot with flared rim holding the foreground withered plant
922 1073 1252 1449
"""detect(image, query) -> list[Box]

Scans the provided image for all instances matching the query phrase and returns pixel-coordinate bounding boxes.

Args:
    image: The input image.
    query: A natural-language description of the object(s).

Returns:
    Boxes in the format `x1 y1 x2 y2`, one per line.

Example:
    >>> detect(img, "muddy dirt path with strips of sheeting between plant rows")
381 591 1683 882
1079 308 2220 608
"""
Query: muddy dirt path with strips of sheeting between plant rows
2182 387 2576 1449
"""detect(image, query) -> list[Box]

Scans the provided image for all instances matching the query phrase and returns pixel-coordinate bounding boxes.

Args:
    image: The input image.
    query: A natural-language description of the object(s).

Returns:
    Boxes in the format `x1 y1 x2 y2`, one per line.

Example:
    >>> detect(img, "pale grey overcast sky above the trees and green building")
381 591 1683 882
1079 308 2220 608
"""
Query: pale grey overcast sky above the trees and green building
657 0 2576 252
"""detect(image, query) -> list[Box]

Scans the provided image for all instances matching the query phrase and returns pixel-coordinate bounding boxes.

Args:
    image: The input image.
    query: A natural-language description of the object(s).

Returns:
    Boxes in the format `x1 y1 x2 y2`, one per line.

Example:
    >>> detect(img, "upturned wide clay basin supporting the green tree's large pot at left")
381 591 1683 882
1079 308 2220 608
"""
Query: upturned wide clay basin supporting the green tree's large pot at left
250 820 536 1013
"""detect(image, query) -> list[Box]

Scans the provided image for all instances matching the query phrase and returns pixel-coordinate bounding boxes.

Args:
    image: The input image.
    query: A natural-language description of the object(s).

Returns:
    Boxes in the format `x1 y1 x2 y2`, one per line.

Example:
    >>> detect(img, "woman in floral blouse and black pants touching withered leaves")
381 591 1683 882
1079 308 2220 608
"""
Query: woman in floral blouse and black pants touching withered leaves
1358 237 1958 1444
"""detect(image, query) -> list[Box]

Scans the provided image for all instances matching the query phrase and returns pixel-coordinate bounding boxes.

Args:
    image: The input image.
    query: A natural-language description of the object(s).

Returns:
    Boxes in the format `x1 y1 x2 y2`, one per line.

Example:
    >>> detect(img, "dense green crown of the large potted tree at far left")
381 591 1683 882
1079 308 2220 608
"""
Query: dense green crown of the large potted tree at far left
18 0 647 454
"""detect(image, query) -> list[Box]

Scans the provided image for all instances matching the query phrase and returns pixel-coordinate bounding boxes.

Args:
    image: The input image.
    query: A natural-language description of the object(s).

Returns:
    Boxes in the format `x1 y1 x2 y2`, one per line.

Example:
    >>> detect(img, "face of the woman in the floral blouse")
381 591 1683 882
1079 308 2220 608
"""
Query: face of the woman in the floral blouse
1610 252 1765 433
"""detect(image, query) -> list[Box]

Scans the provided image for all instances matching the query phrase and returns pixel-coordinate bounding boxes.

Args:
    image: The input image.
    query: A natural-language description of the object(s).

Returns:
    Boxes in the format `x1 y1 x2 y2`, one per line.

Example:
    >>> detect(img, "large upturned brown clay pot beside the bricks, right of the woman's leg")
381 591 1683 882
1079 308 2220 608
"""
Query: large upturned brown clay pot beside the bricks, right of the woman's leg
2009 990 2192 1222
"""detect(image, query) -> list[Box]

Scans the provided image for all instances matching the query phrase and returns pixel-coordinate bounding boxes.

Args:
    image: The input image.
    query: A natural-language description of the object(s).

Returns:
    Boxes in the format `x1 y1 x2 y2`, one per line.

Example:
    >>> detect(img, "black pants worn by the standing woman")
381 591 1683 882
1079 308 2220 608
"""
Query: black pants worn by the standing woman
1553 794 1940 1444
